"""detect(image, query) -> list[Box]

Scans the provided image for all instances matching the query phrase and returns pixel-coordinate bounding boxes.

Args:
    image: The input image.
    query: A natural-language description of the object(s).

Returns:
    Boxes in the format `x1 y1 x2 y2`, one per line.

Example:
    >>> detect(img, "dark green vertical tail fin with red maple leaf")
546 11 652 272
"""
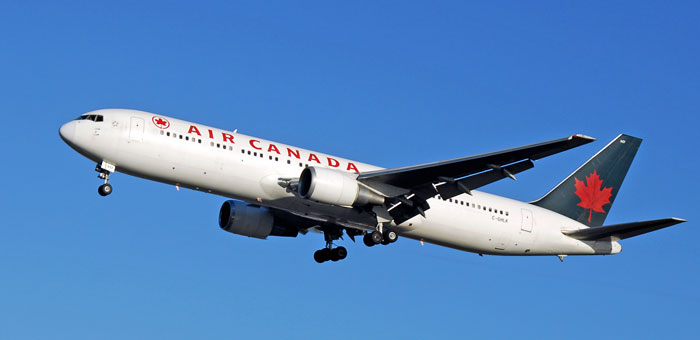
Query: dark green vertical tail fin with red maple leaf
532 135 642 226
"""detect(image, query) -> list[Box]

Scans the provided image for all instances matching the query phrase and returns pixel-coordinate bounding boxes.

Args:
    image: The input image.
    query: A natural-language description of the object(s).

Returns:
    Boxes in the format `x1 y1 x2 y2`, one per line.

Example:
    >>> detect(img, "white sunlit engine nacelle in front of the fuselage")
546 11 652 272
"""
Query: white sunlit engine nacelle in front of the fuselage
298 167 384 206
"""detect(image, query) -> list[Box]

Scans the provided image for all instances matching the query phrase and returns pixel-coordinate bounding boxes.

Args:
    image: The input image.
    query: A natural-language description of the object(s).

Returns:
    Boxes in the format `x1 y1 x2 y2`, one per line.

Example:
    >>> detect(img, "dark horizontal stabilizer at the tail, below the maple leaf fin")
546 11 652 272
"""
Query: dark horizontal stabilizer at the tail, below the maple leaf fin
563 217 685 240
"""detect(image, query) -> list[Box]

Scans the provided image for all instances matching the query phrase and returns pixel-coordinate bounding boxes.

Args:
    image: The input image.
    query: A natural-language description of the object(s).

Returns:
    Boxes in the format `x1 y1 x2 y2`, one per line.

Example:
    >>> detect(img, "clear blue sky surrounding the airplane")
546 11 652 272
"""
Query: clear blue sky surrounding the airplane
0 1 700 339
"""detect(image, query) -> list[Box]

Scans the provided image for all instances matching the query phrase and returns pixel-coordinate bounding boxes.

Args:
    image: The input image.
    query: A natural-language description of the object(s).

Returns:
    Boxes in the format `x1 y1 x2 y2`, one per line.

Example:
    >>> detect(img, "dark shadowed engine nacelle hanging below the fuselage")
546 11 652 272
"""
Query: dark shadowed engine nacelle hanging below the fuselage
219 201 298 239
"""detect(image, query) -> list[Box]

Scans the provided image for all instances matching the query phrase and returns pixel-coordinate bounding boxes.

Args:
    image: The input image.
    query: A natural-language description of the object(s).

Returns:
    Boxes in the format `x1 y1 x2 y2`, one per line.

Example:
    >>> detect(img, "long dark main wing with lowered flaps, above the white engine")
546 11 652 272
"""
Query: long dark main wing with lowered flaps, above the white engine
357 135 595 224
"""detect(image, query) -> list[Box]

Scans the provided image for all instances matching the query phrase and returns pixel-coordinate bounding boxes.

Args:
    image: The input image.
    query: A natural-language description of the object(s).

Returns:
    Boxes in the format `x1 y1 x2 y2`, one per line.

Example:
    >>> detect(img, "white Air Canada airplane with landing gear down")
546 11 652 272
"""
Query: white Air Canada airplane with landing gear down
59 109 685 263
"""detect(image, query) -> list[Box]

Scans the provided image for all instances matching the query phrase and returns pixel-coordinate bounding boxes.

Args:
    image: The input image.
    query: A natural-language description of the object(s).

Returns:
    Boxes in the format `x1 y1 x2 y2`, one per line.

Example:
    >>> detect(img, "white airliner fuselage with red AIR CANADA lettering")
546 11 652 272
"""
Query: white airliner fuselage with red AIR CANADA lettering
61 109 621 255
